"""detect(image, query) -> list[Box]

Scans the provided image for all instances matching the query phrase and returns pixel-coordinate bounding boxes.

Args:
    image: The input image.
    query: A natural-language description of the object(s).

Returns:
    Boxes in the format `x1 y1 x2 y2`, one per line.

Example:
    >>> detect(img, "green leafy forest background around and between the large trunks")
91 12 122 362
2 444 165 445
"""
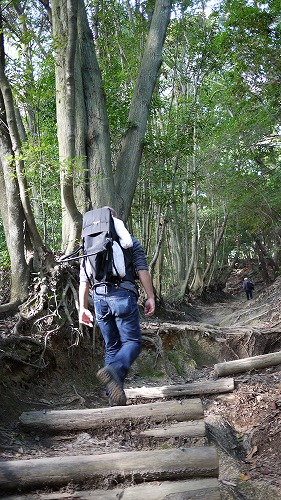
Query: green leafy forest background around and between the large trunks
0 0 281 293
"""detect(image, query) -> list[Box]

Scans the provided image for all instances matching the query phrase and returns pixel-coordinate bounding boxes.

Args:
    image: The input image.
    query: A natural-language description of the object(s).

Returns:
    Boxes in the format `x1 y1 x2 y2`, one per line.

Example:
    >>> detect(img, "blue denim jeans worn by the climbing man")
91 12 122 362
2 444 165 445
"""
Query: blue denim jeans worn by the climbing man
94 287 142 384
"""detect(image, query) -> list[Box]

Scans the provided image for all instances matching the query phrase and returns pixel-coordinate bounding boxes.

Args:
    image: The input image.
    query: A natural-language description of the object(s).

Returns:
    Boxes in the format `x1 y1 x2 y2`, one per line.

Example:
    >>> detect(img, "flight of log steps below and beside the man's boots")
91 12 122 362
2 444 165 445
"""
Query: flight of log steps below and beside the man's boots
0 379 234 500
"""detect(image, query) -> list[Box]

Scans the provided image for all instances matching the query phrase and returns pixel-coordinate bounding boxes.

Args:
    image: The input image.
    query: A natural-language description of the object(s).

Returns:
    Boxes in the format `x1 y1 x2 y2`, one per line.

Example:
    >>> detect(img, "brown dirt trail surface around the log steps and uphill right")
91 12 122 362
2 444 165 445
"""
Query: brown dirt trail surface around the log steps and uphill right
0 279 281 500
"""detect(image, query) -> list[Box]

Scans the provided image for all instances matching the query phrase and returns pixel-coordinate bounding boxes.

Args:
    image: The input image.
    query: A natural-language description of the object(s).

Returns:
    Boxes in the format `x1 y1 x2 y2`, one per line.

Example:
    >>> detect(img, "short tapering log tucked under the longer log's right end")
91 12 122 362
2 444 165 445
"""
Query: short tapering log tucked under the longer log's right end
132 420 206 439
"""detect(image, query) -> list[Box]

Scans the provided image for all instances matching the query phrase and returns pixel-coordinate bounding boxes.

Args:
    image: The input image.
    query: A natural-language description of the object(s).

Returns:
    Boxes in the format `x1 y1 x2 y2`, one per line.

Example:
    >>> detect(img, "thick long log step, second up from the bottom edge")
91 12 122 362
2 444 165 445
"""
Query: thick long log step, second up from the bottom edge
0 447 218 491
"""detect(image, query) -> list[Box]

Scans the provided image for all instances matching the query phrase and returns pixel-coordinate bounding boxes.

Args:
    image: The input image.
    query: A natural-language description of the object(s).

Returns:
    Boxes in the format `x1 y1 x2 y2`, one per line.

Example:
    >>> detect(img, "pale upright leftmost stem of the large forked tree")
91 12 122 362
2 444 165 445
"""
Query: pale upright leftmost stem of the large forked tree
52 0 82 253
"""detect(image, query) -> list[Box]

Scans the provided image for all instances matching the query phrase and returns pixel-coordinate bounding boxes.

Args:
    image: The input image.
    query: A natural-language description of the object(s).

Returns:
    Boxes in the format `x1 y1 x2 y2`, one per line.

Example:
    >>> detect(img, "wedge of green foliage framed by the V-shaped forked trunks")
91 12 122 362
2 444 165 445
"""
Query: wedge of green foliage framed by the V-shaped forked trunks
90 0 149 158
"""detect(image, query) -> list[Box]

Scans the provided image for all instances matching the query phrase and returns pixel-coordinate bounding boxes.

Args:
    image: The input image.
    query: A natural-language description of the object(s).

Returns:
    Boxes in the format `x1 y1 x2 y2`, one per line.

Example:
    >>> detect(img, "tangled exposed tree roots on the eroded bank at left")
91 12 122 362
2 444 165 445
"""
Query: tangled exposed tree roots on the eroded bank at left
0 264 83 376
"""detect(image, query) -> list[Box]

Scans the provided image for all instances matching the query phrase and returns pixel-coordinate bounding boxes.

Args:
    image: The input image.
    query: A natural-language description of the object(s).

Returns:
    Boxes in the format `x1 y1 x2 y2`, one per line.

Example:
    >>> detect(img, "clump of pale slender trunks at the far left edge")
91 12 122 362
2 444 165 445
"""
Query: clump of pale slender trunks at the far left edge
0 9 49 302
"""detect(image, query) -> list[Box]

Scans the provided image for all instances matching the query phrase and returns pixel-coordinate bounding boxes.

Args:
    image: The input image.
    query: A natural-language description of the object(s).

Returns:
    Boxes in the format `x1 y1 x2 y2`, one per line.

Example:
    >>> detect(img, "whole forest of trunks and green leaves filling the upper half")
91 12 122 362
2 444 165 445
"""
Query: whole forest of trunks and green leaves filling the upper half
0 0 281 303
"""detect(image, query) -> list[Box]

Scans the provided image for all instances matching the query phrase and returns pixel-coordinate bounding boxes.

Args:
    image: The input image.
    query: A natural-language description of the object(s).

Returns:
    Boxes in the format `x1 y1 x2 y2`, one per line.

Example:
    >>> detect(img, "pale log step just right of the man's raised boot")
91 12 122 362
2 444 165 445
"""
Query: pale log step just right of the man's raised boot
125 378 234 399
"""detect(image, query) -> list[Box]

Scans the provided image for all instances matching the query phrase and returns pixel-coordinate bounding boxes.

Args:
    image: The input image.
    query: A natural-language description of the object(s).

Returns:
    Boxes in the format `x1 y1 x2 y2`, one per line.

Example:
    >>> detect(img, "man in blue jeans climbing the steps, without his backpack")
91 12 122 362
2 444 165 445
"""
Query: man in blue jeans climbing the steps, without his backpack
79 207 155 406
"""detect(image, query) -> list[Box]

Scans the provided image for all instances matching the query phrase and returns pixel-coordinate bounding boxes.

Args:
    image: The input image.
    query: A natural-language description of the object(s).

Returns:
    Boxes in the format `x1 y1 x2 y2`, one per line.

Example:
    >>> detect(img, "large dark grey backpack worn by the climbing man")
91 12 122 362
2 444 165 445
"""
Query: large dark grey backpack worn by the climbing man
61 208 135 283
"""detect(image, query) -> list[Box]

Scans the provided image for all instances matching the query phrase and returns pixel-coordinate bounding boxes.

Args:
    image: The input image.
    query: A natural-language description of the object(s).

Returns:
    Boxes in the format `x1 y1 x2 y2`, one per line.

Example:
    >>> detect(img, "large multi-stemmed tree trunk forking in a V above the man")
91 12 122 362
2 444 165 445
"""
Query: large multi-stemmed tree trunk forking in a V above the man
52 0 171 252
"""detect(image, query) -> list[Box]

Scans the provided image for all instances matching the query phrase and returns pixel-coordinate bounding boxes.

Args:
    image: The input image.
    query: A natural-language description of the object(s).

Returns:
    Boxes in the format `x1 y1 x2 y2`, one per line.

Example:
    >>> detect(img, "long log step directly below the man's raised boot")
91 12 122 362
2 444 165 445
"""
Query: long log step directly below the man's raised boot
19 399 204 431
